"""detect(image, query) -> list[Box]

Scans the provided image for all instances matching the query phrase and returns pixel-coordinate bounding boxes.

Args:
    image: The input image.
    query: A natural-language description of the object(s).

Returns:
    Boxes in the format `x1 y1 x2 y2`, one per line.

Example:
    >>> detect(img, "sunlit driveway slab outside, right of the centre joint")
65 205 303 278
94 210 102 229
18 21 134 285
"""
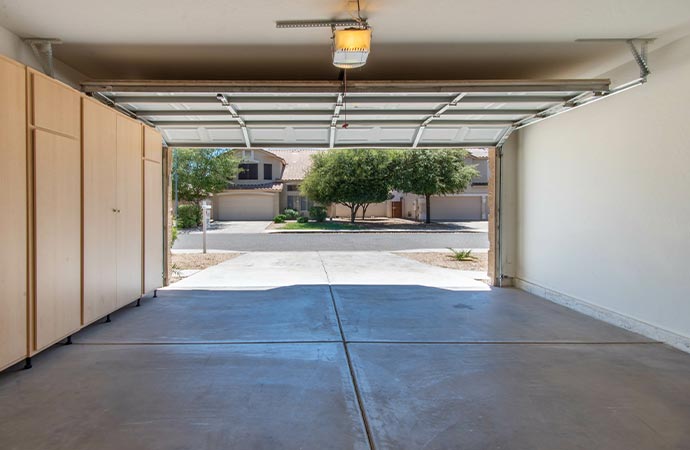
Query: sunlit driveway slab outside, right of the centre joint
319 252 489 291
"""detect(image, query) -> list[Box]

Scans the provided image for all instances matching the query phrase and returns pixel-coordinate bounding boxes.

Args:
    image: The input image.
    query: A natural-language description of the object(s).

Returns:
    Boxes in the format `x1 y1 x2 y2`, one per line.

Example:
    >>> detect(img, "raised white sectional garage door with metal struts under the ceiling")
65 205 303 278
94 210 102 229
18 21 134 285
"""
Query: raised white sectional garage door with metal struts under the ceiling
83 80 609 148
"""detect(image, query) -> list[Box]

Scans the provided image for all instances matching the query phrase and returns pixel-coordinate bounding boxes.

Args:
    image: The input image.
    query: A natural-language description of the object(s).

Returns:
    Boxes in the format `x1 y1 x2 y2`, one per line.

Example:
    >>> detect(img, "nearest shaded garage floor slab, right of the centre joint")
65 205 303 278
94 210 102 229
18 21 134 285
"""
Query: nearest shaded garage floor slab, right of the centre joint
349 344 690 450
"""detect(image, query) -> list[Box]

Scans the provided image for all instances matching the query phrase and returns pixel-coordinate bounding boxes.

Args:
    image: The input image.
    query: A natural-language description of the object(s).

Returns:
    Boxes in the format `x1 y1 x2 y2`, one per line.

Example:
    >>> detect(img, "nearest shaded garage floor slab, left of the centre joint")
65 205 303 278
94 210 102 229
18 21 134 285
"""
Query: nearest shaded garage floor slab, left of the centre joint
0 344 369 450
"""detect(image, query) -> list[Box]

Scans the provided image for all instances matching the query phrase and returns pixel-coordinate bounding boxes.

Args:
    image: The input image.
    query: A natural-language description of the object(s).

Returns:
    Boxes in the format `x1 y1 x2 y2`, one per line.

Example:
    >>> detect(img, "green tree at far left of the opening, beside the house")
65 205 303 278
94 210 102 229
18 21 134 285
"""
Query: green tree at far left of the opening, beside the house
172 148 240 203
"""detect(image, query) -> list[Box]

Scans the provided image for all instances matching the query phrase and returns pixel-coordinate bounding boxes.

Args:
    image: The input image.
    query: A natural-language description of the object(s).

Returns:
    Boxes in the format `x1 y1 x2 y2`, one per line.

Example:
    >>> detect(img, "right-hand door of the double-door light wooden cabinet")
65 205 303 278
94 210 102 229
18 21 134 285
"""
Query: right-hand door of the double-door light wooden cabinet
116 115 143 307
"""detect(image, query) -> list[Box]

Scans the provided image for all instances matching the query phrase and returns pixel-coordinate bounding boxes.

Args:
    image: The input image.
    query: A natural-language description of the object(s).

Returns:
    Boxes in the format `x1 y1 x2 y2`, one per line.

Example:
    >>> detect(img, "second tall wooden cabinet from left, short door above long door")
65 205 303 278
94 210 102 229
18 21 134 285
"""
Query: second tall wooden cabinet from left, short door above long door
27 69 81 354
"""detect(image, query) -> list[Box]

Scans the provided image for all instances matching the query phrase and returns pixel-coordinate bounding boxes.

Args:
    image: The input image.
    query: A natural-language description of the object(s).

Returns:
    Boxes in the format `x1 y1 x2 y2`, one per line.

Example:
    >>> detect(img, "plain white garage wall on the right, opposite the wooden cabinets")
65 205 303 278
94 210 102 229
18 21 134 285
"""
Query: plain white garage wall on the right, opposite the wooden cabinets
513 32 690 351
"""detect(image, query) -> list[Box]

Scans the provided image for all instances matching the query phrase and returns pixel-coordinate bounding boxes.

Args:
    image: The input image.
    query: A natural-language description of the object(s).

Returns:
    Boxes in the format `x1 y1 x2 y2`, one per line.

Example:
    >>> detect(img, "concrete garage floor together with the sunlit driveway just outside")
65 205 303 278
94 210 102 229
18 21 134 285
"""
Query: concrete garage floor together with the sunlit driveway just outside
0 252 690 450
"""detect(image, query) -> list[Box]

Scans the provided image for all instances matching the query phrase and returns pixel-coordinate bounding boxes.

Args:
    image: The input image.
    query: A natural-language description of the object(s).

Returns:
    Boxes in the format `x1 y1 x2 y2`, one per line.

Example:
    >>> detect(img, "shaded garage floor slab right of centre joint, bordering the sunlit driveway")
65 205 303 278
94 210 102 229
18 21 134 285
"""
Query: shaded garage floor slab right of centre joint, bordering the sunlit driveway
333 285 650 343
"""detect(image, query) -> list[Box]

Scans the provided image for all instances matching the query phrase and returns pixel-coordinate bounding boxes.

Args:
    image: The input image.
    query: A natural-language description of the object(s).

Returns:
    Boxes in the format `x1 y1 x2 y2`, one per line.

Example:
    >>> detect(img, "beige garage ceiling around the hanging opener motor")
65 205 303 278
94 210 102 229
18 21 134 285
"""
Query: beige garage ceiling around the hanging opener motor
0 0 690 80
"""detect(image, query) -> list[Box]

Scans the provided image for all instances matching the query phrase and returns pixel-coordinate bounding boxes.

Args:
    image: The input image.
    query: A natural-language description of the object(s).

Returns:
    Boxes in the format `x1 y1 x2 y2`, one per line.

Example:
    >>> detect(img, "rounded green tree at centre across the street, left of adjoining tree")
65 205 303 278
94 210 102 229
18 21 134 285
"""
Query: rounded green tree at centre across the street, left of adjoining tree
300 149 395 222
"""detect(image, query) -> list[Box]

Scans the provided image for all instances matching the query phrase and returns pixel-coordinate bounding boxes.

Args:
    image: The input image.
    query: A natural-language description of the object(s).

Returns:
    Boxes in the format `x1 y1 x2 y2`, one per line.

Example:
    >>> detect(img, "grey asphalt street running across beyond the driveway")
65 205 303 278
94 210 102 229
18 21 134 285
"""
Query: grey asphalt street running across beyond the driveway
173 233 489 252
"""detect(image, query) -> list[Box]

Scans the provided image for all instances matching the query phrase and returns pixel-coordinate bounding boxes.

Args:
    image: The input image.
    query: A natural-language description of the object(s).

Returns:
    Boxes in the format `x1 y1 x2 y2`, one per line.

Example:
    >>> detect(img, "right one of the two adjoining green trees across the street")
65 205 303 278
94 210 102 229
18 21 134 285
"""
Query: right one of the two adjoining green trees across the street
393 149 479 223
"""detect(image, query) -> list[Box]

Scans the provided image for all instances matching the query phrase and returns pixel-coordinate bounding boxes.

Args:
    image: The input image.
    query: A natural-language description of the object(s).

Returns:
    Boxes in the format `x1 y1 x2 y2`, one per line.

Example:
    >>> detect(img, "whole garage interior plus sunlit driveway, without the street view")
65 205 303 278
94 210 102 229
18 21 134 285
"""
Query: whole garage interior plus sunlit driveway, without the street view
0 0 690 449
